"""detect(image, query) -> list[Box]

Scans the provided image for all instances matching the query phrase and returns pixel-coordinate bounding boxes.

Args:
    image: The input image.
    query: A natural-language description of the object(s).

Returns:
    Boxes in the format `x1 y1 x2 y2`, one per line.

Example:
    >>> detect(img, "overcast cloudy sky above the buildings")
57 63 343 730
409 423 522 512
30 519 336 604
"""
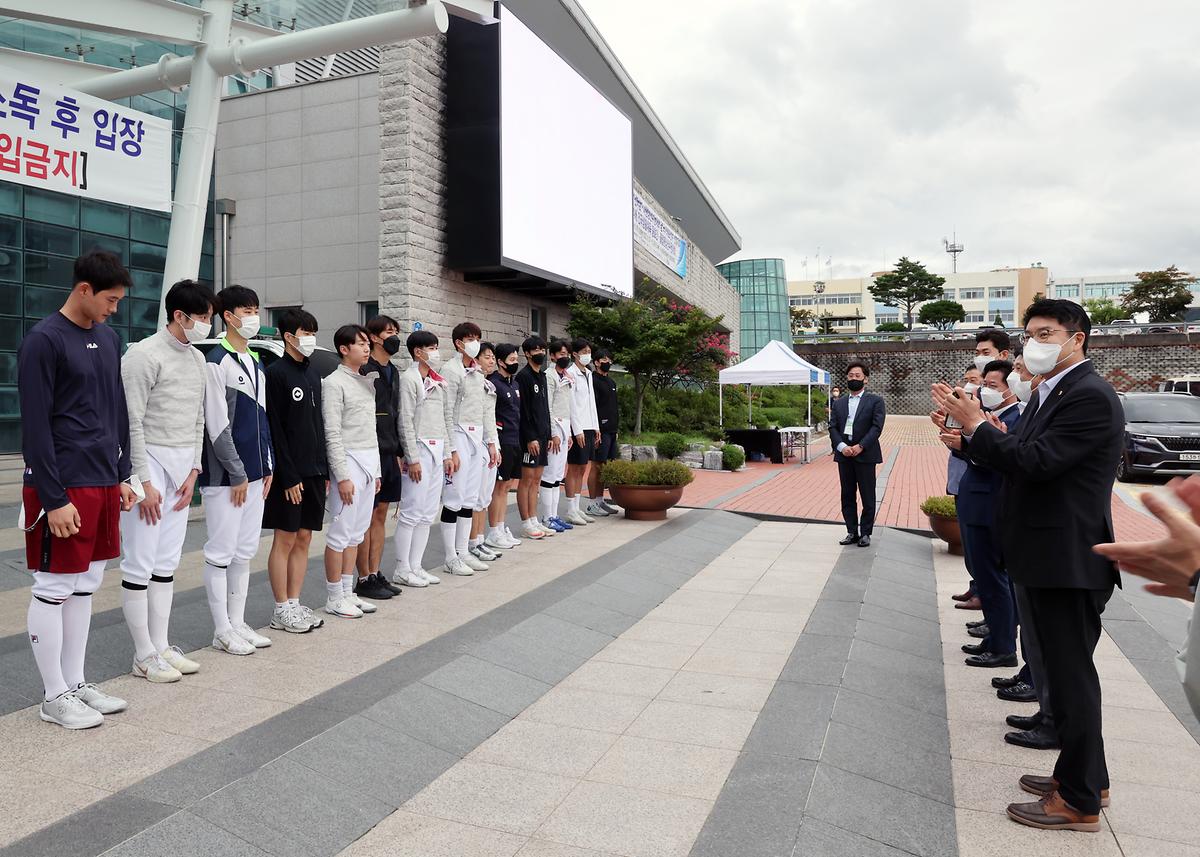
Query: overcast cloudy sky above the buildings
581 0 1200 280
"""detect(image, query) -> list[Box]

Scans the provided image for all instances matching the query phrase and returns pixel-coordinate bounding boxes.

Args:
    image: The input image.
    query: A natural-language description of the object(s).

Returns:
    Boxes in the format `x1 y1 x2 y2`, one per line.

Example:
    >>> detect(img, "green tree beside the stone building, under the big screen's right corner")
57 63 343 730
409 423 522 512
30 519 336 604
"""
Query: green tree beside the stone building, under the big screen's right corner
566 280 734 435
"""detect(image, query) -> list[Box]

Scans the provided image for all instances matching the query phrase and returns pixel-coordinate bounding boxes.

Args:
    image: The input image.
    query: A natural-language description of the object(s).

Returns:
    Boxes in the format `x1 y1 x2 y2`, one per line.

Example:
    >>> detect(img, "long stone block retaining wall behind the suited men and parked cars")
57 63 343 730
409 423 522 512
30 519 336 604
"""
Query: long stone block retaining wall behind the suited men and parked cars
796 334 1200 414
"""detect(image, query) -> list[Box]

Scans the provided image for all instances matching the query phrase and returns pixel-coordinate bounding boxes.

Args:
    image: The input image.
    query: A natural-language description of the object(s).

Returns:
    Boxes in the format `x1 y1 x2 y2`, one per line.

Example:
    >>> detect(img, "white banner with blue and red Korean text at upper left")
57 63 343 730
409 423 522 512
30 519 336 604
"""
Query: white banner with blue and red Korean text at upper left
0 67 170 211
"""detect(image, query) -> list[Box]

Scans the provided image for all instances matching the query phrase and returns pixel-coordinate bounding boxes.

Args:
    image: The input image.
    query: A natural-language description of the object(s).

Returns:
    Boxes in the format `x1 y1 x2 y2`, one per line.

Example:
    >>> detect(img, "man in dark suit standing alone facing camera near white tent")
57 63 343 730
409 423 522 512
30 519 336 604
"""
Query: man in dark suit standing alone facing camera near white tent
829 360 884 547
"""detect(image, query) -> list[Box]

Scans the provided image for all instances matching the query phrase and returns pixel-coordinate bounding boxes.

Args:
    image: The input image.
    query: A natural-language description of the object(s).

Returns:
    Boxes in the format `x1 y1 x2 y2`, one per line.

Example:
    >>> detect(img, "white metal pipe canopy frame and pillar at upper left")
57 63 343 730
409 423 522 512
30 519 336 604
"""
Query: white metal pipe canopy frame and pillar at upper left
0 0 496 324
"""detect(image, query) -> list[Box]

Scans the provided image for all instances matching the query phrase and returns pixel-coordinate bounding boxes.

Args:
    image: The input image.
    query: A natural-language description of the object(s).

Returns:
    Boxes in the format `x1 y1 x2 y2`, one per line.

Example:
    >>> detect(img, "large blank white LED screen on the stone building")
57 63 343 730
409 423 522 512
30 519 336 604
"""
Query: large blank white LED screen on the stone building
499 7 634 298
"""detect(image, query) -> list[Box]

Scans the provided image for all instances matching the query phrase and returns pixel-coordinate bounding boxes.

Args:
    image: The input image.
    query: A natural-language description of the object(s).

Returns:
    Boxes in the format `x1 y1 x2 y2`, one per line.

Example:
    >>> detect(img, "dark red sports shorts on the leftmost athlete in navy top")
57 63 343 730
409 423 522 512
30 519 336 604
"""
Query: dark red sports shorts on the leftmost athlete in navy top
20 485 121 574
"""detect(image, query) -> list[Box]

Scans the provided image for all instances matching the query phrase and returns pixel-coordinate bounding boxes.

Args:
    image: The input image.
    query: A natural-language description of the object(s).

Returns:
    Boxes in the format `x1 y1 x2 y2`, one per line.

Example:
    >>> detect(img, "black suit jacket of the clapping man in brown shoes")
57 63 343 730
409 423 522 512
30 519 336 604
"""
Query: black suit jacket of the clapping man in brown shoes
970 362 1124 591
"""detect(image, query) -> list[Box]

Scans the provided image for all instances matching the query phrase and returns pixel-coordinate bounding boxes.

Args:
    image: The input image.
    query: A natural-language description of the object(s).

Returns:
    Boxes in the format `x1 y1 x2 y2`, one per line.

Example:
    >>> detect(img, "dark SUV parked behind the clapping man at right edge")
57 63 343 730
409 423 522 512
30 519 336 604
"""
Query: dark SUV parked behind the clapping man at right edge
1117 392 1200 483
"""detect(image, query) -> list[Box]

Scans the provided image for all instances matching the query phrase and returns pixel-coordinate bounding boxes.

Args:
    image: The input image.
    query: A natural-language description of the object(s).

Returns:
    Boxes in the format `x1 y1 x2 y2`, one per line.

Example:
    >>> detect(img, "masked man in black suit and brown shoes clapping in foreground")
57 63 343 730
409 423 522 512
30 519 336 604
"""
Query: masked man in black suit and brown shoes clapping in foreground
934 299 1124 832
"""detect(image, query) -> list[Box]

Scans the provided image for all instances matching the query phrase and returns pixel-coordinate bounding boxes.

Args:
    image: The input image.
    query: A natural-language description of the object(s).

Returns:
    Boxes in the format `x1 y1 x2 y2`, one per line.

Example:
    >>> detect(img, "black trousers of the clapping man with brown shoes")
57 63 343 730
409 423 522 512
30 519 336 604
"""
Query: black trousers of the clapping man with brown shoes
1018 586 1112 815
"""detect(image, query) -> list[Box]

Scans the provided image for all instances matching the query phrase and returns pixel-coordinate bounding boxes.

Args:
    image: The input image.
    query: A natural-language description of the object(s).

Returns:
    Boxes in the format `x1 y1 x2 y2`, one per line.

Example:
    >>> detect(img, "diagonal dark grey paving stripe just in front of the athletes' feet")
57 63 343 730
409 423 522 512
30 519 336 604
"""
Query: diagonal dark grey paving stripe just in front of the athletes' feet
0 510 757 857
